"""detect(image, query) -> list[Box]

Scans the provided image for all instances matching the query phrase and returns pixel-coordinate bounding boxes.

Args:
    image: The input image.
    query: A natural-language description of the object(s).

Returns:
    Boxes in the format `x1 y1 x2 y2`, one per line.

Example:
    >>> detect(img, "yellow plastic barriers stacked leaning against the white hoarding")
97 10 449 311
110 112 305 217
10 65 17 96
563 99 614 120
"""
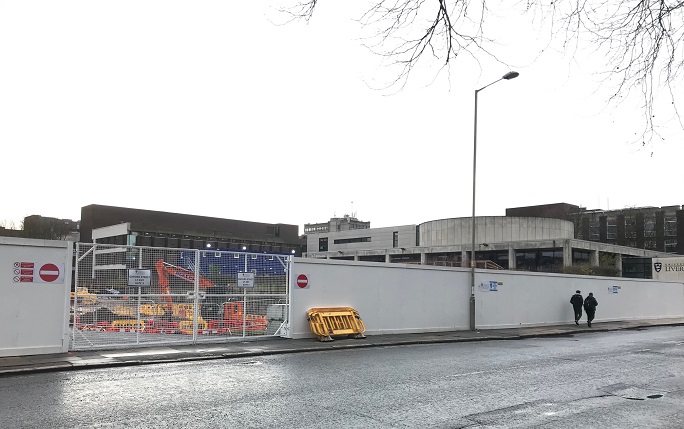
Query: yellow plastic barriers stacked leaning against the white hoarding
306 307 366 341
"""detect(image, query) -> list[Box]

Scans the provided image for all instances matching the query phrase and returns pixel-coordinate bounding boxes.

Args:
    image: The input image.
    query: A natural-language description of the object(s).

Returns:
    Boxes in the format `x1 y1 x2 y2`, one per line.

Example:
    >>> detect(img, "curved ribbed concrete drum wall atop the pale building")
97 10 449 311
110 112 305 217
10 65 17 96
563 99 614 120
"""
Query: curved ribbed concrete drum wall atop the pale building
419 216 574 246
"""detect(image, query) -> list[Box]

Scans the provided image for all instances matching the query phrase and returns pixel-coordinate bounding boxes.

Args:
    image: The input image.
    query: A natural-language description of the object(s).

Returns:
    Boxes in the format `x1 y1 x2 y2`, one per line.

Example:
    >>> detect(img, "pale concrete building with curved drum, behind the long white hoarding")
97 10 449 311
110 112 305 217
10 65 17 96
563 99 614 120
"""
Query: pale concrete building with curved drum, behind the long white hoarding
304 216 667 277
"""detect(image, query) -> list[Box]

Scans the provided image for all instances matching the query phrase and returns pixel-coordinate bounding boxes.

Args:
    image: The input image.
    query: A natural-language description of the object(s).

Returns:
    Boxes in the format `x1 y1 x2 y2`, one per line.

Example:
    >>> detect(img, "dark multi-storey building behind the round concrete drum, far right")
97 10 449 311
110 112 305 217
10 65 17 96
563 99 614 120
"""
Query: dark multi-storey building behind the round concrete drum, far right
506 203 684 255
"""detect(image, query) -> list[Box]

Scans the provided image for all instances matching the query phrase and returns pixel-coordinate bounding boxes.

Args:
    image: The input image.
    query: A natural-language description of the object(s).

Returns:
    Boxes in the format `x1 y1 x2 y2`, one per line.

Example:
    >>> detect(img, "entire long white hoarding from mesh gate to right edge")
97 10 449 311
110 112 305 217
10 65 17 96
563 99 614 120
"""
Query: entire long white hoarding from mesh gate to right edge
290 258 684 338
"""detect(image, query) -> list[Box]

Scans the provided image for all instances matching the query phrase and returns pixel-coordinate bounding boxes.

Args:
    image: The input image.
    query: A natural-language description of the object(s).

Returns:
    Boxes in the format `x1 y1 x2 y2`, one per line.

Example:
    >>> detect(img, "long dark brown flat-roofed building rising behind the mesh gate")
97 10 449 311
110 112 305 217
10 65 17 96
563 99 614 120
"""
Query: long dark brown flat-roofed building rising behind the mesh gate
81 204 305 255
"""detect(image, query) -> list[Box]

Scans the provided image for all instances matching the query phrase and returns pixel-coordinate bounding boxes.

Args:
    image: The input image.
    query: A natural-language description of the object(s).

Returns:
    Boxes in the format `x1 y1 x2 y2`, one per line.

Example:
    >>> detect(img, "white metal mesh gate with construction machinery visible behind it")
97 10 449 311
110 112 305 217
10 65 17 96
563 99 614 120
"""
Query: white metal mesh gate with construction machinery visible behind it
70 243 291 350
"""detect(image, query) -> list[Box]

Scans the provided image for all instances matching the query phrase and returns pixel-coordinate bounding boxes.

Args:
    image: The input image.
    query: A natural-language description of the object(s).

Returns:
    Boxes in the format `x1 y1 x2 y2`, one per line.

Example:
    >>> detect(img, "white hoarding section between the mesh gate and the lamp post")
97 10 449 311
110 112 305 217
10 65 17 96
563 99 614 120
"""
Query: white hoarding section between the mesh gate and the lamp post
290 258 470 338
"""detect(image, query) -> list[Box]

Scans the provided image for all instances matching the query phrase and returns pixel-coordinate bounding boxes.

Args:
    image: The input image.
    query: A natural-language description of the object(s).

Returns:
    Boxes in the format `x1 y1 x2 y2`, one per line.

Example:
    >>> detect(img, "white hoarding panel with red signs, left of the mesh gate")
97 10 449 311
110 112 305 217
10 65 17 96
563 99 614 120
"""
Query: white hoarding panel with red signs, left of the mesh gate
0 237 73 356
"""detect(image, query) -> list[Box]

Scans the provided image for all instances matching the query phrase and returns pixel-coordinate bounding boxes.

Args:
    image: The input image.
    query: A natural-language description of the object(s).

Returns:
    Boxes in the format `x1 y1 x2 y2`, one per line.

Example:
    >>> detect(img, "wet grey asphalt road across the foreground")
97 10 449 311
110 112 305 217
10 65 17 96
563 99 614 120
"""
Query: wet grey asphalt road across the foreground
0 327 684 428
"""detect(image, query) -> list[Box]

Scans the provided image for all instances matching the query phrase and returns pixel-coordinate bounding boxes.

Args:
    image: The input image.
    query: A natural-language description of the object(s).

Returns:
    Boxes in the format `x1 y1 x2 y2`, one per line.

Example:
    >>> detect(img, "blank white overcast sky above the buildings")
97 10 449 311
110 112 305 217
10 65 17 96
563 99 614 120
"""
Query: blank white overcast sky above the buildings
0 0 684 232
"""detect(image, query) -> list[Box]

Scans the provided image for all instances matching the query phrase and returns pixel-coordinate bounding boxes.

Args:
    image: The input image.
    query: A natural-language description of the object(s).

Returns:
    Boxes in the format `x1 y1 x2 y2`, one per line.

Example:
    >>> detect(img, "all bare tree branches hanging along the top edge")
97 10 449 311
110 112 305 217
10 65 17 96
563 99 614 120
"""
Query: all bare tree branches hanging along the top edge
289 0 684 145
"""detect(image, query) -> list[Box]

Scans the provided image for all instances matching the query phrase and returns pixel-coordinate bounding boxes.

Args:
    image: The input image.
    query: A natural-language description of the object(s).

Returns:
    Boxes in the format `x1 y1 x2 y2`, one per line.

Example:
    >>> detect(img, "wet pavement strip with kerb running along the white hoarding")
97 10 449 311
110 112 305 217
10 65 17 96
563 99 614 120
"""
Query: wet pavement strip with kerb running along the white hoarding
0 318 684 377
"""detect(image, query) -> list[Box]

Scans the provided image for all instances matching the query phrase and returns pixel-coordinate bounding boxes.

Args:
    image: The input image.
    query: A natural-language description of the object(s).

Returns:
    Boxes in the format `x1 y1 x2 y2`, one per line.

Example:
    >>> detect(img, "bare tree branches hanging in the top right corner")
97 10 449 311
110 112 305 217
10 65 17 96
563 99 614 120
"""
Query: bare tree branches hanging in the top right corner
527 0 684 146
